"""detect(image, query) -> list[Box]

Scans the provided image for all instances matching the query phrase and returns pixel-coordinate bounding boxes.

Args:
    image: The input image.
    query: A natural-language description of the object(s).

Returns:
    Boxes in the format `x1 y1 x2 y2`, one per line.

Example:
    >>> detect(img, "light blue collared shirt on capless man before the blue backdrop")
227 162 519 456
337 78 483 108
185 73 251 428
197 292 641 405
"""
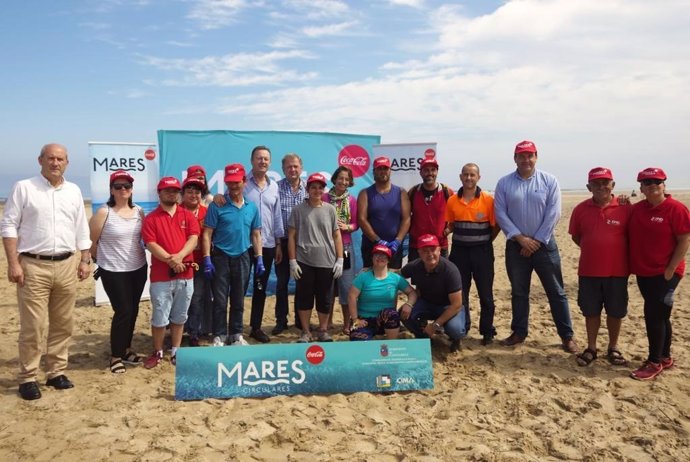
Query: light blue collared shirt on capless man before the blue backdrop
244 172 285 248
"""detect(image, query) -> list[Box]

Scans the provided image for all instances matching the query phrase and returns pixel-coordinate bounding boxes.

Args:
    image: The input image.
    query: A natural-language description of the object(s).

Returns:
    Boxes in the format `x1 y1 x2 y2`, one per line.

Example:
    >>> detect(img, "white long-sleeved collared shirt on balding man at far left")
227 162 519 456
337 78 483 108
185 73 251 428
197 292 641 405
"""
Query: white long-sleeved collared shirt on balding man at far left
0 175 91 255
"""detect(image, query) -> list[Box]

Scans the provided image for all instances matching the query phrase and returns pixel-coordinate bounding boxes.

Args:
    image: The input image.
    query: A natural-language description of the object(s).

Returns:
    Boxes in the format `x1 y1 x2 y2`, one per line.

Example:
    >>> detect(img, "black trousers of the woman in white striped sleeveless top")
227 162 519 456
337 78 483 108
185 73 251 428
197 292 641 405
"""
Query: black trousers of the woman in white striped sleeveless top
101 264 148 358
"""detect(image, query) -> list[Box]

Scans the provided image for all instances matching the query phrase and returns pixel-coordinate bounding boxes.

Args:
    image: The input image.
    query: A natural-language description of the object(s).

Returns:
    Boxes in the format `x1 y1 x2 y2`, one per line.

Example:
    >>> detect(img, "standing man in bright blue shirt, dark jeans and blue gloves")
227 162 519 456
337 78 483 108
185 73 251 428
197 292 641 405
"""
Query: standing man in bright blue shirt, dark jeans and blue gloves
202 164 263 346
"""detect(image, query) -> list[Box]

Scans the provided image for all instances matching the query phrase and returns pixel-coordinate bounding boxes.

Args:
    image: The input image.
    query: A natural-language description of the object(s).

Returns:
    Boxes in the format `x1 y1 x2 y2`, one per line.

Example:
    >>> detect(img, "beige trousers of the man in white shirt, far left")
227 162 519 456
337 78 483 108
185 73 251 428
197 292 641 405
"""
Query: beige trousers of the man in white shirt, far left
17 252 80 384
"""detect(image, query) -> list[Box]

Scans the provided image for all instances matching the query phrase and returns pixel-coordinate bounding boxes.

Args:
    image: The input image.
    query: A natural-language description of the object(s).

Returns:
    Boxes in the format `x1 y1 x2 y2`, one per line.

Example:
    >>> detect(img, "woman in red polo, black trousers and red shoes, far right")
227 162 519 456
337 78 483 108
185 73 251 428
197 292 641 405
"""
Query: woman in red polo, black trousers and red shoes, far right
628 167 690 380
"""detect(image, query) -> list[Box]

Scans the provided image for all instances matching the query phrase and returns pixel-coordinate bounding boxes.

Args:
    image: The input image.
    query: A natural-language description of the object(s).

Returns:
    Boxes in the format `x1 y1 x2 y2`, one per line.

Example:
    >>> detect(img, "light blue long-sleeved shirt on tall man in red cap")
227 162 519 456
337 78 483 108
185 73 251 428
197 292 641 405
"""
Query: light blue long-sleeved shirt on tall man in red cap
494 170 561 244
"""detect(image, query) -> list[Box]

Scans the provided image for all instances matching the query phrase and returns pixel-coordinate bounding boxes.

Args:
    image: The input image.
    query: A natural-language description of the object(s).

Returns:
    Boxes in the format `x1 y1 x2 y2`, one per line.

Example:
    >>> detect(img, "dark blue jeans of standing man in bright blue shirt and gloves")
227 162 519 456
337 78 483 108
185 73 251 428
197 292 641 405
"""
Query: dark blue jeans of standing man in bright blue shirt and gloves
212 250 251 335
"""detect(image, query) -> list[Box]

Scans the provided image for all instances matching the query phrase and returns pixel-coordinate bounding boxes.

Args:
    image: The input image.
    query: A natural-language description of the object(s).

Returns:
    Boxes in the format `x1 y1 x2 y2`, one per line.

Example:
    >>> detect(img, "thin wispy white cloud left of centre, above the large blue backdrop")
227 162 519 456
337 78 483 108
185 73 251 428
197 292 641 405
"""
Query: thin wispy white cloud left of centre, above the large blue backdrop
141 50 317 87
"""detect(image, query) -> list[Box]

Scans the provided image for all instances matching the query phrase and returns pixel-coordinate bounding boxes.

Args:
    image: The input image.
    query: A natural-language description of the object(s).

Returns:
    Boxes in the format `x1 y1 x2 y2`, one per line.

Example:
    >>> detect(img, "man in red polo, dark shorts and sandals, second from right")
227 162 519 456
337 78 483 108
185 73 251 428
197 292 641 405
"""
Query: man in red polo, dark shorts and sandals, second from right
568 167 632 366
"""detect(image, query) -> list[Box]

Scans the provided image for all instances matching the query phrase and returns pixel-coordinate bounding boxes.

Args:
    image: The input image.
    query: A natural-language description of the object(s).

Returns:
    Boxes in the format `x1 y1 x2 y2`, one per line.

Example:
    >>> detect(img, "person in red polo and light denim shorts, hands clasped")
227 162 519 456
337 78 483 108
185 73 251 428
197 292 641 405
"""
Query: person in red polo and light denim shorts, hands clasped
141 176 199 369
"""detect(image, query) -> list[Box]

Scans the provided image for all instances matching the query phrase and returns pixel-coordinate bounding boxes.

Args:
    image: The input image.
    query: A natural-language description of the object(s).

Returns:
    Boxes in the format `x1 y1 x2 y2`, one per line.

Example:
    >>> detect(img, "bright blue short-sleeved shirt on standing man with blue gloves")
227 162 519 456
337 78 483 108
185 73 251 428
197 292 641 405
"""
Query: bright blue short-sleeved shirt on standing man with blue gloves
204 194 261 257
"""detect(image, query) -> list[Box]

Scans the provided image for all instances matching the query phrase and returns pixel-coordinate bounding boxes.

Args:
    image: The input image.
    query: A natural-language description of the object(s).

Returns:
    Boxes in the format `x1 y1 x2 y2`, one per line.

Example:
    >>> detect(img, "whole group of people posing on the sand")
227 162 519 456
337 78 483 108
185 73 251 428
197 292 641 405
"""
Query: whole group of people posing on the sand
0 141 690 400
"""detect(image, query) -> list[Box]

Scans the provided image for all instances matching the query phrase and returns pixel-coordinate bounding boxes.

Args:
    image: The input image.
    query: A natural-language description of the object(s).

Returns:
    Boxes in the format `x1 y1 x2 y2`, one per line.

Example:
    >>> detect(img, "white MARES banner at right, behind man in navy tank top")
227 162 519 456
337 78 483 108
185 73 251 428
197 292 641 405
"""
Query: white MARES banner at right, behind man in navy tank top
372 143 436 190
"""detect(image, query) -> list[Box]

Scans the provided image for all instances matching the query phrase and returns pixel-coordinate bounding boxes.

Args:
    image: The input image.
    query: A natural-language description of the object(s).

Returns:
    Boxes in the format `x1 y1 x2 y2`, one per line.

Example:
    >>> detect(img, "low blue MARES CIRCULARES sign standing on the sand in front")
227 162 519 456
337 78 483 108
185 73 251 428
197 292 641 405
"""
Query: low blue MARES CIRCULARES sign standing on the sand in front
175 339 434 400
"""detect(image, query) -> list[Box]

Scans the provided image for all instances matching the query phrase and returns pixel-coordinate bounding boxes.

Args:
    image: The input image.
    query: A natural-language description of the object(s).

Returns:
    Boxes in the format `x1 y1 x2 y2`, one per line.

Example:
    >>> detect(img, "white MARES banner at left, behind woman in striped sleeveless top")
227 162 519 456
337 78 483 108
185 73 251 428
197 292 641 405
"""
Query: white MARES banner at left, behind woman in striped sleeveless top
89 142 159 305
